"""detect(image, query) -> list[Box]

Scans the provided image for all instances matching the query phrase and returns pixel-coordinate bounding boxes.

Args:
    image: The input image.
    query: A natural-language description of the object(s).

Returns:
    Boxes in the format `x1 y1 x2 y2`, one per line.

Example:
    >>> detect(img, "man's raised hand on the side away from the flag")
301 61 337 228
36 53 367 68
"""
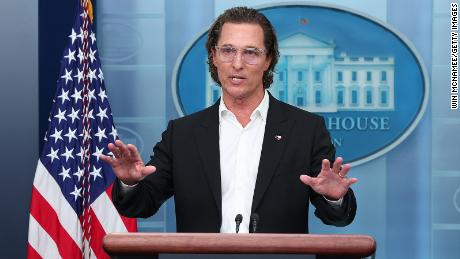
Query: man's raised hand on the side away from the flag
300 157 358 200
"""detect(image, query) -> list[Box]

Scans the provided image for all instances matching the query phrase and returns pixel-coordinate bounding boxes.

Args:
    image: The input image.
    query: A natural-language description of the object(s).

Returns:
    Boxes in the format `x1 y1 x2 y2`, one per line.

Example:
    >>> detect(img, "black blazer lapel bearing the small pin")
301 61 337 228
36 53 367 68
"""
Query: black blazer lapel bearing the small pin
251 95 293 212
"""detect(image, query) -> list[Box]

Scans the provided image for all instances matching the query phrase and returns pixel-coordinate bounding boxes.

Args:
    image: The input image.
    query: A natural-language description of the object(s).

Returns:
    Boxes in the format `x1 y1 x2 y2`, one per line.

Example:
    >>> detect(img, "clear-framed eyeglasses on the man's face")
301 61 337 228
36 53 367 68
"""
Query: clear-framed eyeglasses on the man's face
215 46 267 65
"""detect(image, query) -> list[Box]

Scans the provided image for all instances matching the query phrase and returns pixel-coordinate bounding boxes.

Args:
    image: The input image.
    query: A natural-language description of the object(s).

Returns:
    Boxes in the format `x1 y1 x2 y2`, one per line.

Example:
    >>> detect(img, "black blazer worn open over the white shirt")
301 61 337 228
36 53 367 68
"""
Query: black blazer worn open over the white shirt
113 95 356 233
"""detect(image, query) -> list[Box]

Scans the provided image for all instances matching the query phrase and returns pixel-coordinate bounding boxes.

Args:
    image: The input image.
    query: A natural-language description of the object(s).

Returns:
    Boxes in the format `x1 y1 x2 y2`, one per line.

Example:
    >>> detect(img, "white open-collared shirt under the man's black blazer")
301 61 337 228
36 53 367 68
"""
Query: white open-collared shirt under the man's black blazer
219 90 269 233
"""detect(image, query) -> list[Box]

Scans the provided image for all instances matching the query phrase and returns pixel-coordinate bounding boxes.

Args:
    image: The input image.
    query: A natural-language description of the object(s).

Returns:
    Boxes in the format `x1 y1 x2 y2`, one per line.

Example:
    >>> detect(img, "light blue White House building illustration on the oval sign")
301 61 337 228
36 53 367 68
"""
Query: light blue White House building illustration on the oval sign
206 33 394 112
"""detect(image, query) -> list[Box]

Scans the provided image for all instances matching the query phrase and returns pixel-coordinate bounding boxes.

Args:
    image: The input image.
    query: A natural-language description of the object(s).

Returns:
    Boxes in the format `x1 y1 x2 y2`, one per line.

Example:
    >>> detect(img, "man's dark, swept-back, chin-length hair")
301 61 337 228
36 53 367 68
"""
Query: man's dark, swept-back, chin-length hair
206 7 279 88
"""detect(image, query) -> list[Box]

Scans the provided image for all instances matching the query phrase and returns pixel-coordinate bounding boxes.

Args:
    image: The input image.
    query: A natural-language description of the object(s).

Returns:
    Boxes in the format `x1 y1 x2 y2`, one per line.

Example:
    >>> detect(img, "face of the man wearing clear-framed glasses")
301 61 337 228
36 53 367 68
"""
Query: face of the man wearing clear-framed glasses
213 23 271 100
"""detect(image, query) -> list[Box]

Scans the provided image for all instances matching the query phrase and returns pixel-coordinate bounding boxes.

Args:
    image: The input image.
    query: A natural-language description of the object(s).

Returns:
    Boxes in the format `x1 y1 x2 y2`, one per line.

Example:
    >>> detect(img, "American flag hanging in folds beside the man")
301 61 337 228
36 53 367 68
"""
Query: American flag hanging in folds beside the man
27 0 137 258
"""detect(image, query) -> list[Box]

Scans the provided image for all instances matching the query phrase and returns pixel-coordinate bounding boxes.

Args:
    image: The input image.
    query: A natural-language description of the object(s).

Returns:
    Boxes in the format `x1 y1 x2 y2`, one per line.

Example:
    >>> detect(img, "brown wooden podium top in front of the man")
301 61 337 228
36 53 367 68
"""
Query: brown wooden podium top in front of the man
103 233 376 259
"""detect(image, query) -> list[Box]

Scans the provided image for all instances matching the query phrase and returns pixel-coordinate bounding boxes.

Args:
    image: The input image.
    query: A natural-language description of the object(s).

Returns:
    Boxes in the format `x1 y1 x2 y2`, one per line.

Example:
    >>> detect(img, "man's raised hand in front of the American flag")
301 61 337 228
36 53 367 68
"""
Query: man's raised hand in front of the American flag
100 140 156 185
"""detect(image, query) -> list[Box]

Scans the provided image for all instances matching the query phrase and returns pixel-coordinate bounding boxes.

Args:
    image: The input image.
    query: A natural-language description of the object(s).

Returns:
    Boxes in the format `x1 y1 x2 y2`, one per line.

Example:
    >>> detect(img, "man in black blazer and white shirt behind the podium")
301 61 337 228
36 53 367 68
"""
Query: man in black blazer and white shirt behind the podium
101 7 357 233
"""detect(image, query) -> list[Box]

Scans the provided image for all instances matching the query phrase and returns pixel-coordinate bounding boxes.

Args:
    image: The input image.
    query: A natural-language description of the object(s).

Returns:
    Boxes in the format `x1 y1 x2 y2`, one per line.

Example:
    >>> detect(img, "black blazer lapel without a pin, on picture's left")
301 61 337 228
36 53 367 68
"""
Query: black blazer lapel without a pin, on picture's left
195 101 222 217
